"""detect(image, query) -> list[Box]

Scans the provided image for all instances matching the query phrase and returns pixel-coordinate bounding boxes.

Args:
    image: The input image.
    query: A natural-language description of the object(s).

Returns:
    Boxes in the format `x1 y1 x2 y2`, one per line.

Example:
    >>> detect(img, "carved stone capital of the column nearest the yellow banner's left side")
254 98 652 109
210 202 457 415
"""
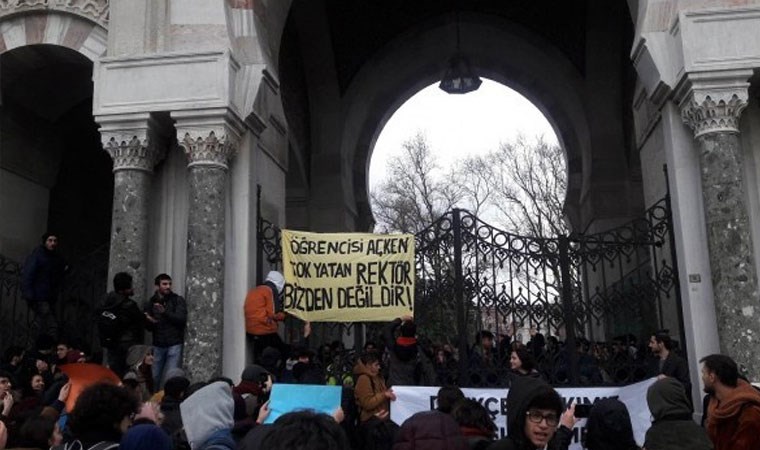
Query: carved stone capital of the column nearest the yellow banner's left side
172 110 243 170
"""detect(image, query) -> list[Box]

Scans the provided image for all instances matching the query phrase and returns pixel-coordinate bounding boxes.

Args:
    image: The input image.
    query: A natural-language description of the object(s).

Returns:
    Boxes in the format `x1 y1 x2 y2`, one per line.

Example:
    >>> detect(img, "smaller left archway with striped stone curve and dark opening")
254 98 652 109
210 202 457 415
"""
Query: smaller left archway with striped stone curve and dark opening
0 9 113 348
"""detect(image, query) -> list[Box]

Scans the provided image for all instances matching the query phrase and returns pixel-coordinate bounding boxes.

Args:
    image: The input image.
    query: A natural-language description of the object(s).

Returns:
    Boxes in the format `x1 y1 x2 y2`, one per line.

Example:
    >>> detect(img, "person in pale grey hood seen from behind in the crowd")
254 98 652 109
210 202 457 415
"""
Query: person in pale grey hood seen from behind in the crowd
179 381 235 450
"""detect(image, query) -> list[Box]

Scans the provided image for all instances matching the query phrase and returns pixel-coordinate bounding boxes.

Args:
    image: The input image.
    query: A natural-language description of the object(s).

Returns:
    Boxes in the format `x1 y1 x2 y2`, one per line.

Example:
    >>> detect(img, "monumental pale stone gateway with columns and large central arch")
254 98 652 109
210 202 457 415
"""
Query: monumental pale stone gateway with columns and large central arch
0 0 760 414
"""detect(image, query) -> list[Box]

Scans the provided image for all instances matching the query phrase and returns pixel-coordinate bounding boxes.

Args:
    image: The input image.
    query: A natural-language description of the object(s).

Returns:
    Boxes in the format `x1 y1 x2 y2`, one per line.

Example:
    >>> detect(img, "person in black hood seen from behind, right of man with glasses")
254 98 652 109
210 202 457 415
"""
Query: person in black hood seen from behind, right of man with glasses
583 398 639 450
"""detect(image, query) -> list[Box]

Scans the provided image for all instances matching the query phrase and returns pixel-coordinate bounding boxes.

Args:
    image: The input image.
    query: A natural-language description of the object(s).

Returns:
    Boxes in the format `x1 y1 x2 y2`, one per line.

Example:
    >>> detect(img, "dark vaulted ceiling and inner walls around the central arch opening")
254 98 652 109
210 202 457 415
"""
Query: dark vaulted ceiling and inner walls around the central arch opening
278 0 633 232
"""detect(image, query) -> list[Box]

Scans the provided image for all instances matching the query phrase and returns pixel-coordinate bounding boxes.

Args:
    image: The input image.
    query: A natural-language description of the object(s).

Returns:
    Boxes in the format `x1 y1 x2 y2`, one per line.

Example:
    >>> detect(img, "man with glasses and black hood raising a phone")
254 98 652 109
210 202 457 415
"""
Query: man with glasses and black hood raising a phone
488 377 576 450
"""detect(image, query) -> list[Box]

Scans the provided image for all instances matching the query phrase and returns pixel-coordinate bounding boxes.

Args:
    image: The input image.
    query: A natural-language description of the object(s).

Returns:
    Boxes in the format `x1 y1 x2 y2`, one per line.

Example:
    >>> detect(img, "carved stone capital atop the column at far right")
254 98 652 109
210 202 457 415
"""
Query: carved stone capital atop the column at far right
677 71 752 138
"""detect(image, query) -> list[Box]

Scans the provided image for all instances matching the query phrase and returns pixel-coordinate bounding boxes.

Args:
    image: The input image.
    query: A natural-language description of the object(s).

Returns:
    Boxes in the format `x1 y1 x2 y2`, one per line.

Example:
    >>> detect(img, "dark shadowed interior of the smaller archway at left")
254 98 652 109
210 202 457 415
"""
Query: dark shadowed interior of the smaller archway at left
0 45 113 264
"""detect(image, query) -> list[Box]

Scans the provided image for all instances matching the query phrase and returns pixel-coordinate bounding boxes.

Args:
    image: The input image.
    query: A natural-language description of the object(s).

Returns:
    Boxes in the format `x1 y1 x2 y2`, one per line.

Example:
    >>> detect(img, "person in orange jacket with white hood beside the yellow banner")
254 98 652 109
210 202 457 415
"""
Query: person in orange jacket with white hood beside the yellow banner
244 271 287 363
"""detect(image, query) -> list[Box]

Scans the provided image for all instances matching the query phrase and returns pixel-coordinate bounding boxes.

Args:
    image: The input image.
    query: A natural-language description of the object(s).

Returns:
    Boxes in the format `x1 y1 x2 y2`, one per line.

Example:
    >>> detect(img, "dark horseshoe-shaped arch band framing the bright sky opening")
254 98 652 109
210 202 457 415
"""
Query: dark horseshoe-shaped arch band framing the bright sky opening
341 14 593 232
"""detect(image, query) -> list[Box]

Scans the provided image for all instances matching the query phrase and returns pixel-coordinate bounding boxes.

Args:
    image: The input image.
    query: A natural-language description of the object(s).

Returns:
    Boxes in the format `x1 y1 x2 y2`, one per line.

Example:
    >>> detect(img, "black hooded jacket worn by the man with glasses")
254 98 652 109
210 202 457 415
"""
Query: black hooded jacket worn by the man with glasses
488 377 573 450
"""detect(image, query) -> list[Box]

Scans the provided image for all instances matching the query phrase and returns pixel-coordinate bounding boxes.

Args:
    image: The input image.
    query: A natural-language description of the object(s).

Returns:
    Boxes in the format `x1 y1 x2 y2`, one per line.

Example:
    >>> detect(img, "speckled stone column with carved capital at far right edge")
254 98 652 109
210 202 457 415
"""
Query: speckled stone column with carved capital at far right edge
681 71 760 374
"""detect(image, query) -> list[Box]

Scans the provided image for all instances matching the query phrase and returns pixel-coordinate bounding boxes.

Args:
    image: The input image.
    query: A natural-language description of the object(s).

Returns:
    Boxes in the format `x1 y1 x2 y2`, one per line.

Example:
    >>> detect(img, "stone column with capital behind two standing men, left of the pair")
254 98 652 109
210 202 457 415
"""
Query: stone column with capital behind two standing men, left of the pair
98 114 163 302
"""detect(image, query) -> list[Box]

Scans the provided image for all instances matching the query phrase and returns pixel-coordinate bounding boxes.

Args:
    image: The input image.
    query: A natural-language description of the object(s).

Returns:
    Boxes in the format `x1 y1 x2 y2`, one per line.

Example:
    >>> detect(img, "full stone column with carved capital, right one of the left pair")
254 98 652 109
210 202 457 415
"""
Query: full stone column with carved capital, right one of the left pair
172 110 242 381
